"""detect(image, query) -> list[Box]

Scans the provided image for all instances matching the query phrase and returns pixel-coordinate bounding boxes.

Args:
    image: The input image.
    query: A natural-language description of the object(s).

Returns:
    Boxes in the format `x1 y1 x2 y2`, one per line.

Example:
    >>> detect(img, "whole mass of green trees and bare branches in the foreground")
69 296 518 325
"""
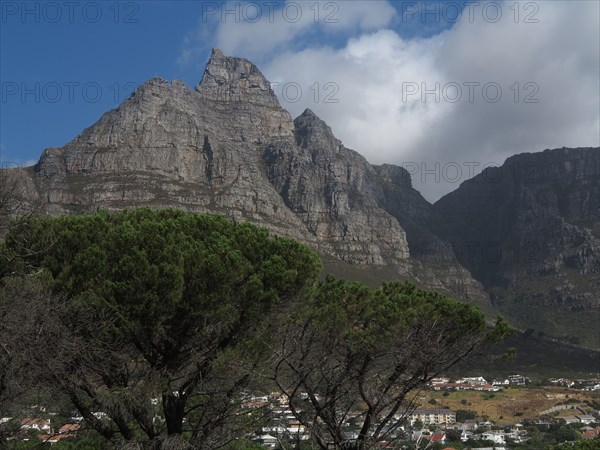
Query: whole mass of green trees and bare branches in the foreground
0 209 510 449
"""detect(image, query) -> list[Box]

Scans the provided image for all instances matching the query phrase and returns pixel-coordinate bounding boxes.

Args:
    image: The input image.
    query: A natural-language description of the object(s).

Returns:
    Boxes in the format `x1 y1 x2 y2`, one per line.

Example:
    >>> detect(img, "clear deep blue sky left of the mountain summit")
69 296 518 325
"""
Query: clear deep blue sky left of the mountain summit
0 2 200 162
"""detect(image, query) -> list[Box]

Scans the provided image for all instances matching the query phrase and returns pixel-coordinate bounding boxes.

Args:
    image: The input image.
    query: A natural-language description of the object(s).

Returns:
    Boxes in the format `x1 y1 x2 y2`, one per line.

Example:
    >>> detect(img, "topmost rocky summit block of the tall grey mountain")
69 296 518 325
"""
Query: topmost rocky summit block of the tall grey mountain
196 48 279 106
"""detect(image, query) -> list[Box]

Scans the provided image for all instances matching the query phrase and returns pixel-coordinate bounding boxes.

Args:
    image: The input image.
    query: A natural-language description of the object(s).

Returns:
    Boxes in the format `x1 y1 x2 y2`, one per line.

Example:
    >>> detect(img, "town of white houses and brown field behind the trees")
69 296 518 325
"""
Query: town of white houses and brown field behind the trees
0 374 600 450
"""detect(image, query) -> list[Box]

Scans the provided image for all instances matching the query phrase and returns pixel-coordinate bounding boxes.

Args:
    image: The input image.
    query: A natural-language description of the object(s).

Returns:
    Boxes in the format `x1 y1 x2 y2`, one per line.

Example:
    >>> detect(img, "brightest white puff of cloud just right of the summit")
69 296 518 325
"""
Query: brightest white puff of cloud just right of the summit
264 30 449 162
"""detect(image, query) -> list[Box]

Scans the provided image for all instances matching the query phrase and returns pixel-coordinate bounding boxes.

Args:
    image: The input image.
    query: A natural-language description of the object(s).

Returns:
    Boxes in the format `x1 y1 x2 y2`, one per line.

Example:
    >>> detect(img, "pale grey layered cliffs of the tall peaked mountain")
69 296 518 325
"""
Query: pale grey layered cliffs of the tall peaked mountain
3 49 488 304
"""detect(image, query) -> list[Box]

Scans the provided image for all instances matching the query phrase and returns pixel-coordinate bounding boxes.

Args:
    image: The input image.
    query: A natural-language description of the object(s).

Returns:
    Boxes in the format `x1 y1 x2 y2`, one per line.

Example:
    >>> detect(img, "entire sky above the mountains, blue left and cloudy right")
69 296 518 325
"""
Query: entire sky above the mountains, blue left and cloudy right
0 0 600 202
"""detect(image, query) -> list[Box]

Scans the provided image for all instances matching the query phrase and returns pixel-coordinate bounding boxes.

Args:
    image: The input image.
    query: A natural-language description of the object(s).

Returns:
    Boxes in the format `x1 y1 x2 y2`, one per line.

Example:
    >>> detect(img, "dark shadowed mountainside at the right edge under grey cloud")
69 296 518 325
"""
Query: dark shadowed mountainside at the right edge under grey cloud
433 148 600 345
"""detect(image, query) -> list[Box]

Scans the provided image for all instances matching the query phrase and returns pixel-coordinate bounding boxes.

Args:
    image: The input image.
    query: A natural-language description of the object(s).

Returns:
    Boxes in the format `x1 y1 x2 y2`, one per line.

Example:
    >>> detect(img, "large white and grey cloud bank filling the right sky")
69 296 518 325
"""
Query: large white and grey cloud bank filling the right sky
183 1 600 200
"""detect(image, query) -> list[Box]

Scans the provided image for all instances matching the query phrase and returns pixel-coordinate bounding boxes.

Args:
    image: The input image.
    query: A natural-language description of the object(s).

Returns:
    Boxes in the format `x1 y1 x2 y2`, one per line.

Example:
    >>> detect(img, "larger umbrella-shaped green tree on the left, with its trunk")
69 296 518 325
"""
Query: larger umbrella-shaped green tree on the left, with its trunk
3 209 321 448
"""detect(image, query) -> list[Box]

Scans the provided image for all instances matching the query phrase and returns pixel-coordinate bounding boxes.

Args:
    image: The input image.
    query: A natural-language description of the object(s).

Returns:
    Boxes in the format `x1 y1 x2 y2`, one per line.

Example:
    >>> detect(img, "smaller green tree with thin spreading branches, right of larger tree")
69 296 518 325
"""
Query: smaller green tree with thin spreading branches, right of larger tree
274 276 511 449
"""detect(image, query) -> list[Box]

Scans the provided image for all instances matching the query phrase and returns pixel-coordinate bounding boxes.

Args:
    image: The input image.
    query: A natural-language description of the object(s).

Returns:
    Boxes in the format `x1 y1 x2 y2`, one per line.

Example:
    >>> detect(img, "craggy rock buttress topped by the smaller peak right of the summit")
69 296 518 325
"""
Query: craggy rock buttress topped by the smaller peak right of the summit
264 110 409 272
